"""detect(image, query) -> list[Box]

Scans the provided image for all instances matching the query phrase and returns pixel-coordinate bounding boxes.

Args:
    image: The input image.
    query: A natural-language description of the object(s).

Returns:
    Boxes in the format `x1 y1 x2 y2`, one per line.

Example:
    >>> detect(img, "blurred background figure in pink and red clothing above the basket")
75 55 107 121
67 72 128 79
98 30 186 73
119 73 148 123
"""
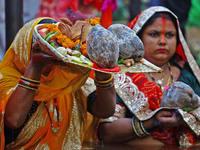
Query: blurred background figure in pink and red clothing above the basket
36 0 117 28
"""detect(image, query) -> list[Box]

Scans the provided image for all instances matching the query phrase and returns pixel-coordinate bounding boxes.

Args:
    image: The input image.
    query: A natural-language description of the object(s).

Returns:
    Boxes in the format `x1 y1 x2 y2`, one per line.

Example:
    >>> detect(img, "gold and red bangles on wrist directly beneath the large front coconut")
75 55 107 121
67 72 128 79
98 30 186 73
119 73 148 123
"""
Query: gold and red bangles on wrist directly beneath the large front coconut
94 74 114 89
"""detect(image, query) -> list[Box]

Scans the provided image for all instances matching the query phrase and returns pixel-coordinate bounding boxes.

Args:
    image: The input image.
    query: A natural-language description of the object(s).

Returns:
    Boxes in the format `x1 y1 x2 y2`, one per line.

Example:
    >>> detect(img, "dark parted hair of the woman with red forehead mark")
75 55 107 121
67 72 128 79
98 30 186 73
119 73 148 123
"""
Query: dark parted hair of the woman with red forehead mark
137 12 179 42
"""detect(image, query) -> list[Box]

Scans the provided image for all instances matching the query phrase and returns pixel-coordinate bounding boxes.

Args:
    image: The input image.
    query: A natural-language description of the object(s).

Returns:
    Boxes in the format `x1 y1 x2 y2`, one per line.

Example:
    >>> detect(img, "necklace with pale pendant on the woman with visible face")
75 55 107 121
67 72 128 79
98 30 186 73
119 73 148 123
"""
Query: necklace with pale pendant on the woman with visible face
148 62 174 91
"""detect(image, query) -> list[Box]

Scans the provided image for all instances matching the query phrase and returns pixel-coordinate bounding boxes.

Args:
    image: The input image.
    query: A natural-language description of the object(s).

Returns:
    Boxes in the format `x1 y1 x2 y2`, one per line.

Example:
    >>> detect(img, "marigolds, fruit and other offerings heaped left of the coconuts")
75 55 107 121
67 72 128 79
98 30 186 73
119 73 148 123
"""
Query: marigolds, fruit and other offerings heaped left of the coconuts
36 18 100 67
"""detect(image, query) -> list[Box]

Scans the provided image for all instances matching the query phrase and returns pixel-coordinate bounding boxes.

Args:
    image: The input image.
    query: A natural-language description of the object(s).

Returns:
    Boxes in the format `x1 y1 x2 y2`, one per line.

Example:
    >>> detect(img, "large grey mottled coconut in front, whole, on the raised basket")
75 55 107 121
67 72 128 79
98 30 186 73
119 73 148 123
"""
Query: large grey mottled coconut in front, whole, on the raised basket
86 25 119 68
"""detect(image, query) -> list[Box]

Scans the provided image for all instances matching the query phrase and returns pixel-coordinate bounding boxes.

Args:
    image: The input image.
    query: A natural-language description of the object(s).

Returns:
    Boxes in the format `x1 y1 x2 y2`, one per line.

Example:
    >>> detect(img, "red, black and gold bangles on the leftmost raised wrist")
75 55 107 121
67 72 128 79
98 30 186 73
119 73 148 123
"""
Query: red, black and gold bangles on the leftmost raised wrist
18 77 40 90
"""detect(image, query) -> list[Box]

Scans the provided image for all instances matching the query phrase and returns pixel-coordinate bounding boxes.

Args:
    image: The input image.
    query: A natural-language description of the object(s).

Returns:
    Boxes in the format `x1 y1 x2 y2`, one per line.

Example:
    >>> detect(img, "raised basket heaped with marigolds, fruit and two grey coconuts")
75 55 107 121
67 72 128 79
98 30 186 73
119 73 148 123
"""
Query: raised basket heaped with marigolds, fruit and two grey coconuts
33 17 161 73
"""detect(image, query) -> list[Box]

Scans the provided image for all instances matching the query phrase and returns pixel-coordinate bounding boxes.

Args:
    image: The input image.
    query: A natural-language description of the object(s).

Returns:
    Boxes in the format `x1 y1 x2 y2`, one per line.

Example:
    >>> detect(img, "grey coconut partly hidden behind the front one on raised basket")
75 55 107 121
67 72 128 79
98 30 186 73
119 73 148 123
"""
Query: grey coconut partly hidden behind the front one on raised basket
108 24 144 67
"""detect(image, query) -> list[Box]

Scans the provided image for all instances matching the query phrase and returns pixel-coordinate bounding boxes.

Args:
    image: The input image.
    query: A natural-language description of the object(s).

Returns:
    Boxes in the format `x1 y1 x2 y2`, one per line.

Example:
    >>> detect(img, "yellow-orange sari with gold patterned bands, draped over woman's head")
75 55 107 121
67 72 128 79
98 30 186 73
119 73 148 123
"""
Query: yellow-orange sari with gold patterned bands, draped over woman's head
0 18 97 150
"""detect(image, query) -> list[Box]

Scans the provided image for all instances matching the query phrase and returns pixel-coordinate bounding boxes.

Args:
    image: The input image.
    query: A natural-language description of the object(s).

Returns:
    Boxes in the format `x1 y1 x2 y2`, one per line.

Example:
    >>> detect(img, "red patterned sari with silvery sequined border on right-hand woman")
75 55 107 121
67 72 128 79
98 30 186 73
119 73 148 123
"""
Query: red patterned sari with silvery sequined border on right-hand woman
104 6 200 146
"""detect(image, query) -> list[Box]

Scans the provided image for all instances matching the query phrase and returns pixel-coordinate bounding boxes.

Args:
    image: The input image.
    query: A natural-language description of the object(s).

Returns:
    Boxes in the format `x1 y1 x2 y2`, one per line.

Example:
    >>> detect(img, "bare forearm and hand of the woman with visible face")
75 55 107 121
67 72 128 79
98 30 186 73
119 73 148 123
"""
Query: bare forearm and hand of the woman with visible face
98 110 183 143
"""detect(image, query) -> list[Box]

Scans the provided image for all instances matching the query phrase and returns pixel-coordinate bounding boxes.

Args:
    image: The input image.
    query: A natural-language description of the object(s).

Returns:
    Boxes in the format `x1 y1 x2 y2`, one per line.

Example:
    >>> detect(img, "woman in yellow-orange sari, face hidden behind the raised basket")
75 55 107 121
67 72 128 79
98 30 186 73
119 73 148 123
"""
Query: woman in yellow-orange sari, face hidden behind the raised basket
0 18 116 150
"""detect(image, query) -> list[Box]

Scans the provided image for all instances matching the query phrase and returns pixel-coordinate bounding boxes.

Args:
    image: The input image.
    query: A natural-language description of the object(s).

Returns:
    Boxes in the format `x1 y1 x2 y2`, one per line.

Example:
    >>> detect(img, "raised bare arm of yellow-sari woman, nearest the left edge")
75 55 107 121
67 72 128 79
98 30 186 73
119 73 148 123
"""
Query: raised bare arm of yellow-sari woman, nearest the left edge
5 43 62 129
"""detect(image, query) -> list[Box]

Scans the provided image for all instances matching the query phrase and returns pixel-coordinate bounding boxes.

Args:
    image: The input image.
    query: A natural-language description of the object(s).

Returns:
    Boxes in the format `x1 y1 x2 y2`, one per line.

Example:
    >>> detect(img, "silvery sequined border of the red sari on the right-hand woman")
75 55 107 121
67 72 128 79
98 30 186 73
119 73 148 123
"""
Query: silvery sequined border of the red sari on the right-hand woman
103 6 200 145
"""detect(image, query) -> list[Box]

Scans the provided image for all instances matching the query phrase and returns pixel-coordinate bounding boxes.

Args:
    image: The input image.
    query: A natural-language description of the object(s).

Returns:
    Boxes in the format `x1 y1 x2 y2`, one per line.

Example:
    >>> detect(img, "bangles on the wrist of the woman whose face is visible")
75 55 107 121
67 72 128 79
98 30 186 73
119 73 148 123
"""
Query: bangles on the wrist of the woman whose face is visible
132 117 151 137
